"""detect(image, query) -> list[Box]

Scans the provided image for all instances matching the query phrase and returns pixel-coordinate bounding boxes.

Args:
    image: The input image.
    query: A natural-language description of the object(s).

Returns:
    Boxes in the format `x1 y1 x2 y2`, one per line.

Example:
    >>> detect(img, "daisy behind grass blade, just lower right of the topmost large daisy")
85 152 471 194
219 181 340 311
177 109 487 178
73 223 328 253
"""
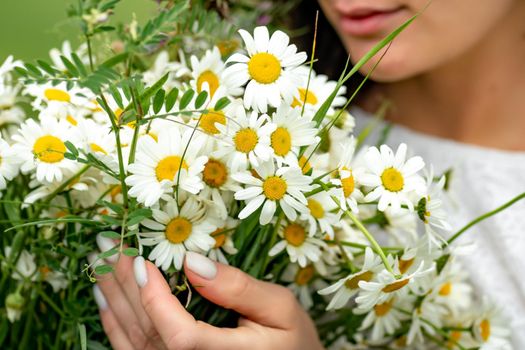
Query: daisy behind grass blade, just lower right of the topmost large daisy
292 66 346 114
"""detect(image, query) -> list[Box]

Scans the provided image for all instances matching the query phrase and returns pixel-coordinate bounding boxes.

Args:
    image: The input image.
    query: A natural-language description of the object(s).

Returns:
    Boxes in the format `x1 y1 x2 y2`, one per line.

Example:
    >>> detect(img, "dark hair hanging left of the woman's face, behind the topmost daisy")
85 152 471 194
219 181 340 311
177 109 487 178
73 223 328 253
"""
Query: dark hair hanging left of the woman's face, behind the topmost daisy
282 0 370 96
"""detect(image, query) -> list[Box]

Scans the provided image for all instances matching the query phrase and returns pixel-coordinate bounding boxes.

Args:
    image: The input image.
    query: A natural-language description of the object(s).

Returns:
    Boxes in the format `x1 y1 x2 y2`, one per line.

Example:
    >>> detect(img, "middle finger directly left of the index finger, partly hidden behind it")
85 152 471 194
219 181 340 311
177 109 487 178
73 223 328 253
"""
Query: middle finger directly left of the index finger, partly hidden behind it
111 247 164 349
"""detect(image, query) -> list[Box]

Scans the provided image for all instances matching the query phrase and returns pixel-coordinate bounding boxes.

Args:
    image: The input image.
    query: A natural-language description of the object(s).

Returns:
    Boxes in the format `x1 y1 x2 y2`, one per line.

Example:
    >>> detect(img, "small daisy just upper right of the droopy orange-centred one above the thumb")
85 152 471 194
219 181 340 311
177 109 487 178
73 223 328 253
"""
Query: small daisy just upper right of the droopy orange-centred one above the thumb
301 191 340 239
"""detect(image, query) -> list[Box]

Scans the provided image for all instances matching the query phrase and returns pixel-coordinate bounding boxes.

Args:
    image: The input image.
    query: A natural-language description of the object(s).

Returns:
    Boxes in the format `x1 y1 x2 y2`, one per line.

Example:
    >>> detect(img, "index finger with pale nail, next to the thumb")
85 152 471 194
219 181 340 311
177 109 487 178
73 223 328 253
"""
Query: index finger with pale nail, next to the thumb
133 256 253 350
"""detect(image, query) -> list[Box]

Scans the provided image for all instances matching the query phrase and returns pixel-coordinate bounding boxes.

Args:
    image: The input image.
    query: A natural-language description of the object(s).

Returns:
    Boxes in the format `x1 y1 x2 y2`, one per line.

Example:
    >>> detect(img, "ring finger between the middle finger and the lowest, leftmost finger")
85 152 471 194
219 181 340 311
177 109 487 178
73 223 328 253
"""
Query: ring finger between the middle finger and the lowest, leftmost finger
97 266 148 349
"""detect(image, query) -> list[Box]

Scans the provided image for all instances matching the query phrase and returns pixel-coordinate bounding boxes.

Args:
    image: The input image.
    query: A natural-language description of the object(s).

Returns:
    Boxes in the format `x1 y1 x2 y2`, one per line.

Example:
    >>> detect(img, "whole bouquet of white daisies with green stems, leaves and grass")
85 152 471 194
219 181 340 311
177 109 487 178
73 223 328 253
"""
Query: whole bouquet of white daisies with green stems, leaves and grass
0 0 517 349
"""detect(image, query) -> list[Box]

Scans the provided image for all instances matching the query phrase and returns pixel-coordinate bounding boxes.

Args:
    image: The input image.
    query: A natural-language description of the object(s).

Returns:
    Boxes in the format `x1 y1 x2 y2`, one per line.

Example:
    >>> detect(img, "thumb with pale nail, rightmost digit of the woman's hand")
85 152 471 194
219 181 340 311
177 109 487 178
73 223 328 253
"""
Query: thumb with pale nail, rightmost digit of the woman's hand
184 252 299 329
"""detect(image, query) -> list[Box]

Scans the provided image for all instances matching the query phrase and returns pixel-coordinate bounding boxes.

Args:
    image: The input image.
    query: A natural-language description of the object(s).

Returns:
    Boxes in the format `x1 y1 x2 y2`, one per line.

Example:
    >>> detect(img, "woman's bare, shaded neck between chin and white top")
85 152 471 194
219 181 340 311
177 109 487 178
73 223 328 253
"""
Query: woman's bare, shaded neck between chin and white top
363 4 525 150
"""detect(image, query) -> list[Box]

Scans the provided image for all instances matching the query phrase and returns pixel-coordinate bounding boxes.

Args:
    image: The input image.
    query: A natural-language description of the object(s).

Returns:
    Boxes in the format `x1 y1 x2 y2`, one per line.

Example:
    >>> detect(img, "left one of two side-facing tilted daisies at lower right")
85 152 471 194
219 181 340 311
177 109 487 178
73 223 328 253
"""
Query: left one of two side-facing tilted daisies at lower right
318 247 382 310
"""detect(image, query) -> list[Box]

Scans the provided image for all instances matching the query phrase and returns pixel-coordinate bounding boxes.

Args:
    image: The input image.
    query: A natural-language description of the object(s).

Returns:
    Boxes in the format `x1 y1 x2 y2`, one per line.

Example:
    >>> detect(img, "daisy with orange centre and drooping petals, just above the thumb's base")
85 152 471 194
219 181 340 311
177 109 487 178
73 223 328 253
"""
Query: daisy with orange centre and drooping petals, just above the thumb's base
268 222 325 267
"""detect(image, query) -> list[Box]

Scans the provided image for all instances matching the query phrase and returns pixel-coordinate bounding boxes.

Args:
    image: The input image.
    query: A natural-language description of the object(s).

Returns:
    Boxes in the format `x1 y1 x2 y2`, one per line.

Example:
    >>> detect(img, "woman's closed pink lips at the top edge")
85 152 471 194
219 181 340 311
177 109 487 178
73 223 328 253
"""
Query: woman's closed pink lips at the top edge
340 7 404 36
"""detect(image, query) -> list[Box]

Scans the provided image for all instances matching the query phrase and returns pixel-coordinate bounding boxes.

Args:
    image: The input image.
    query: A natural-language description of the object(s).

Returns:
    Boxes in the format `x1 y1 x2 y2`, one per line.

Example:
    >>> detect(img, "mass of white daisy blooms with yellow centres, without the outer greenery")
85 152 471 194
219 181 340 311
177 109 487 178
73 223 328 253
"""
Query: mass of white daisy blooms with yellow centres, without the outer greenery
0 27 508 349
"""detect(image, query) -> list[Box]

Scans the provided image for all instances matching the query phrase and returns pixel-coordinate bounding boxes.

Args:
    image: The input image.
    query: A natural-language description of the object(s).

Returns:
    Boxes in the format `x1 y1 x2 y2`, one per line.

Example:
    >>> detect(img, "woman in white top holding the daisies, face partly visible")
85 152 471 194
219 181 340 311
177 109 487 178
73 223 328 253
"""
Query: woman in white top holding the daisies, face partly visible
95 0 525 349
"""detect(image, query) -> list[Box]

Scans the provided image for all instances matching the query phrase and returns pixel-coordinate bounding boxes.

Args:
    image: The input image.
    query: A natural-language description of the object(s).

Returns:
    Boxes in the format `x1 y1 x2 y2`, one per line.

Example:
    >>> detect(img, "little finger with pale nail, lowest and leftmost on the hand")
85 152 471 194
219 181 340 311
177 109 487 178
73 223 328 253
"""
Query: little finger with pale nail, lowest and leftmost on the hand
93 286 134 350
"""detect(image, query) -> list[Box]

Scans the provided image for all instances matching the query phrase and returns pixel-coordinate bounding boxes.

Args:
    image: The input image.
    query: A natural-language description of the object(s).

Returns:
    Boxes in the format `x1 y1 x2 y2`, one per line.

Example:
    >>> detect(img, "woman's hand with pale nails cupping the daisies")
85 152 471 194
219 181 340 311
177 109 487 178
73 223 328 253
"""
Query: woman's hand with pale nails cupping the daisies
94 238 322 350
